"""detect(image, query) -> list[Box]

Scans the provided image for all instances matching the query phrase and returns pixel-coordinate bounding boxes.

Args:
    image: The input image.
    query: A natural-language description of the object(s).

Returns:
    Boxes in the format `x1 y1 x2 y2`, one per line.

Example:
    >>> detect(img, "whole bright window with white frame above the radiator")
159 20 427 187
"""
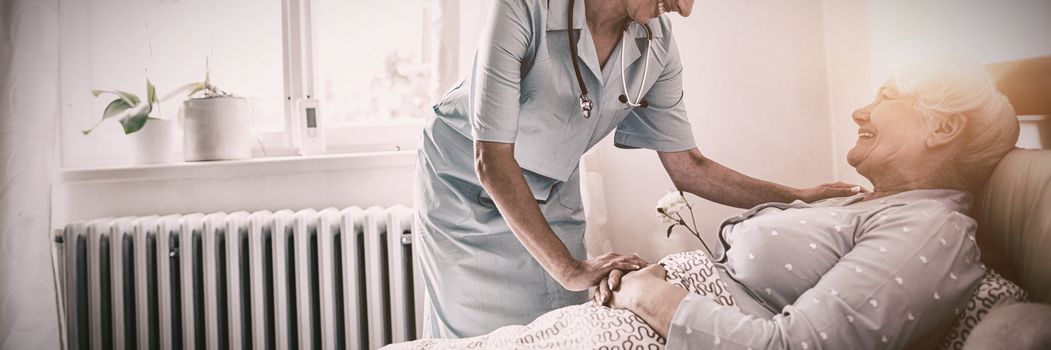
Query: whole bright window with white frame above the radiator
60 0 460 166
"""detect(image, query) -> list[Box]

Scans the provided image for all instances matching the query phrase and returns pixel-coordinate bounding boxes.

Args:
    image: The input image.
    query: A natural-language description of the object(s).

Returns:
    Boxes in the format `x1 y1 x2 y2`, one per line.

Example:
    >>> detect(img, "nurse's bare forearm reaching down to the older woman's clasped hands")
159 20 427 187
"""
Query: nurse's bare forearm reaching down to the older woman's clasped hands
474 141 590 288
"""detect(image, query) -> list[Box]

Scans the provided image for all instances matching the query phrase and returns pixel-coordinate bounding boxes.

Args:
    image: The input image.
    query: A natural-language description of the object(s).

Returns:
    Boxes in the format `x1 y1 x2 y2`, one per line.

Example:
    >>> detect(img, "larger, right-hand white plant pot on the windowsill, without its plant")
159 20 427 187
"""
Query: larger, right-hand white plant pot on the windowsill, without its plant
182 97 252 162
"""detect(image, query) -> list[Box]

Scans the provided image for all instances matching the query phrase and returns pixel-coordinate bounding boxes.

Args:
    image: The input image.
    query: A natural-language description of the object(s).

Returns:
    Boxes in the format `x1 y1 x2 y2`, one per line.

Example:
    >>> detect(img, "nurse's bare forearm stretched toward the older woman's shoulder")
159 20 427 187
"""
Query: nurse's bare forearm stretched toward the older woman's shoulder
658 148 799 208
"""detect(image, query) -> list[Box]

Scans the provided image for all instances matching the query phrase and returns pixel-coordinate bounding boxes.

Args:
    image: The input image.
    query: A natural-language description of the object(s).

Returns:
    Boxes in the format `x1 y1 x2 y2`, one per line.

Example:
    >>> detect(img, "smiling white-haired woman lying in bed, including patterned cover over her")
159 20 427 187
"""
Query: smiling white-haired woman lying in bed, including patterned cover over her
392 64 1018 349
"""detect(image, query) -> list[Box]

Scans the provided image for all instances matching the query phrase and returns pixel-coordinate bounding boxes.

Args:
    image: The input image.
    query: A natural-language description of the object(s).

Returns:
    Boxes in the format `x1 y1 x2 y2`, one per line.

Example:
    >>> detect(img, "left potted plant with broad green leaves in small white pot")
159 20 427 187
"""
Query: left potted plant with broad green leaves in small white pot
82 79 174 164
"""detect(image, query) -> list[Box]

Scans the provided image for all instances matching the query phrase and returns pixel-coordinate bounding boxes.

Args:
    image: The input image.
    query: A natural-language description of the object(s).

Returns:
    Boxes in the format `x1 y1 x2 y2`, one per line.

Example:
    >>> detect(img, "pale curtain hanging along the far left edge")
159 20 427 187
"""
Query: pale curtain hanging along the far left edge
0 0 60 350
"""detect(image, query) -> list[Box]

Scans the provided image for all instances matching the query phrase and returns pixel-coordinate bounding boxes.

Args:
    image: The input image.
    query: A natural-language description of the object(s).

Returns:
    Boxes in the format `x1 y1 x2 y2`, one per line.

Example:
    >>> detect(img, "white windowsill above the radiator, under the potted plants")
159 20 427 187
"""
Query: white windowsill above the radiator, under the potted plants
59 150 416 184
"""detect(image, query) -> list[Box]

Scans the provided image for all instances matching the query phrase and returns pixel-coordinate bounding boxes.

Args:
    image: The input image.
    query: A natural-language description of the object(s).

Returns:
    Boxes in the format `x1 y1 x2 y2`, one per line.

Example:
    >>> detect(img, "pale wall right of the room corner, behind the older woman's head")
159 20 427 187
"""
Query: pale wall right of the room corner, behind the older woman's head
824 0 1051 188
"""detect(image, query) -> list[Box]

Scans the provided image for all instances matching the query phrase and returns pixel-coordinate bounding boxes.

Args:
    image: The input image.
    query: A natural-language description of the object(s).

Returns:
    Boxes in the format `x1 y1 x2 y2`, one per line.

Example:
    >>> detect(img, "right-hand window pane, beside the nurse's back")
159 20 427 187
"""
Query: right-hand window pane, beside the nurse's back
312 0 432 124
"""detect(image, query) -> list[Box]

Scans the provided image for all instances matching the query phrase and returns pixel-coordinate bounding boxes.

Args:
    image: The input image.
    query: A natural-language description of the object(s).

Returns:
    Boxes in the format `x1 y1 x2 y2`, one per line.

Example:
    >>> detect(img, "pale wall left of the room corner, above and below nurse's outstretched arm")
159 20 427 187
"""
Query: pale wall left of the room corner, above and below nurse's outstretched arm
589 0 833 260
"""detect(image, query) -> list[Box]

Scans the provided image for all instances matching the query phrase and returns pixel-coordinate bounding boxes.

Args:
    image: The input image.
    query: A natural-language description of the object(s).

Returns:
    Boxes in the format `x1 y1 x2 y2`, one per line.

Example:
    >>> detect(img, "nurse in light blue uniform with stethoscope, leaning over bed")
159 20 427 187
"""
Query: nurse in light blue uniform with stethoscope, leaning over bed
414 0 854 337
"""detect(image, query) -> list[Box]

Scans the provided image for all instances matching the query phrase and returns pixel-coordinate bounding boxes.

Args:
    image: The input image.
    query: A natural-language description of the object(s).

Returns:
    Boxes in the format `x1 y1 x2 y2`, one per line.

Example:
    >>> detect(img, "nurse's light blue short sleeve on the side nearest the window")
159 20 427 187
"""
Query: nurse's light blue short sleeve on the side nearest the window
470 0 533 143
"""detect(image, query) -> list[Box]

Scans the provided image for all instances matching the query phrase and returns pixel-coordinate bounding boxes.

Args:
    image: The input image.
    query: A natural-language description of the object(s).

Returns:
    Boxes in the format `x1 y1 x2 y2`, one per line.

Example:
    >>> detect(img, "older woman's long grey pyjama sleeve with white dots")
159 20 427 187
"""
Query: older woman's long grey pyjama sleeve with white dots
668 206 984 349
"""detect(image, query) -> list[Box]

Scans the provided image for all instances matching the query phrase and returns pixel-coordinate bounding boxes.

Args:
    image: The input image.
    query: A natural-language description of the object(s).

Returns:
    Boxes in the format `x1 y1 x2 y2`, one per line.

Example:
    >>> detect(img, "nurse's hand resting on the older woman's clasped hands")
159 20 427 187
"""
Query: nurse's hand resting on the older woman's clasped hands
554 253 650 291
